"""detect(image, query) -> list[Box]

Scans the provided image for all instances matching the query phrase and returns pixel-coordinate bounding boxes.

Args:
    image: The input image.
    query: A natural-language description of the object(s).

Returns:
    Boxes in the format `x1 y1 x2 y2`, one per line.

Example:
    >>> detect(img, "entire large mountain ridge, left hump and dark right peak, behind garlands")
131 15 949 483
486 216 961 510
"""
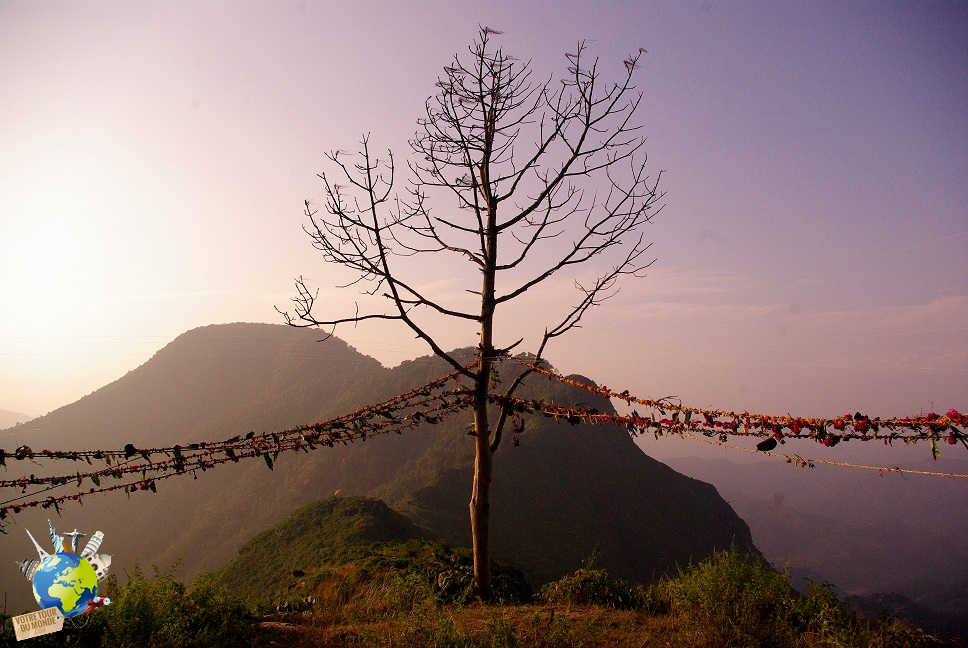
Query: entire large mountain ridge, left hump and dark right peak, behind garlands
0 324 755 612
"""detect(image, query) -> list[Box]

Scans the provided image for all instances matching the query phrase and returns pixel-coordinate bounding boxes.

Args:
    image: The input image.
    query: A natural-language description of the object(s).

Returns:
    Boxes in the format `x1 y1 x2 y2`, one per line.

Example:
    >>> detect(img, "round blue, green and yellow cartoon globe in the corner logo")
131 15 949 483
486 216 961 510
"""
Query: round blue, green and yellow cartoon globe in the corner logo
33 551 97 617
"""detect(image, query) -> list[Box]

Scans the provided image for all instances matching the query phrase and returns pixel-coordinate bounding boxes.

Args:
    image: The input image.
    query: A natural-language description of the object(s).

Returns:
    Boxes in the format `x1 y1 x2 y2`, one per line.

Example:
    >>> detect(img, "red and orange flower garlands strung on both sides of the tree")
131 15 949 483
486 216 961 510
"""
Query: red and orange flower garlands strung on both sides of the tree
0 354 968 532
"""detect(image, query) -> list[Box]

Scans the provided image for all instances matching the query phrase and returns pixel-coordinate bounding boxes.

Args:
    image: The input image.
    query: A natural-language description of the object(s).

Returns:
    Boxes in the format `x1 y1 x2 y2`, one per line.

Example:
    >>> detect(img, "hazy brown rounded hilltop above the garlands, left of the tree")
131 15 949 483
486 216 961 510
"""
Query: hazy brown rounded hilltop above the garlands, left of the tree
5 324 386 448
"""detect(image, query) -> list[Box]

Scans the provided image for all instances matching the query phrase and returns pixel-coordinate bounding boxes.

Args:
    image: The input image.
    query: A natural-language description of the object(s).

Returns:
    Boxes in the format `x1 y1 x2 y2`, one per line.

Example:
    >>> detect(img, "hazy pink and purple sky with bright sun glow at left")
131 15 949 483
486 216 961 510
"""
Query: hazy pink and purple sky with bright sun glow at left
0 0 968 466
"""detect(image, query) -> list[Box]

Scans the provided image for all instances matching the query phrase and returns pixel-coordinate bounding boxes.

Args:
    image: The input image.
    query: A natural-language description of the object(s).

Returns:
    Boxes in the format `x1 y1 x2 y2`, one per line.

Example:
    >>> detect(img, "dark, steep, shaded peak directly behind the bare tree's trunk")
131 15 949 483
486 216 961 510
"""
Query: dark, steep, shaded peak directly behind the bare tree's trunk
388 376 752 584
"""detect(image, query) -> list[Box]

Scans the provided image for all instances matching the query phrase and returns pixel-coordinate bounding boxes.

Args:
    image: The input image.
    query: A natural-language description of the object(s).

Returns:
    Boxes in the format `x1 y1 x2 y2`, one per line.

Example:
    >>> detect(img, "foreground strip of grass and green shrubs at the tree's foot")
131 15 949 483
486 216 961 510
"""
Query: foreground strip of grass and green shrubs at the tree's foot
0 542 944 648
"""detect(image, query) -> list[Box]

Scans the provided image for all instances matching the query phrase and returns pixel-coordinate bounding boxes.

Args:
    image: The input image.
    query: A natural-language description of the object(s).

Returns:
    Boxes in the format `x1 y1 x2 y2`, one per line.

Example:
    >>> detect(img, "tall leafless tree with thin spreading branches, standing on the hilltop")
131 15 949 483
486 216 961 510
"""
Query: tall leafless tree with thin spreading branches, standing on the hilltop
283 27 662 599
